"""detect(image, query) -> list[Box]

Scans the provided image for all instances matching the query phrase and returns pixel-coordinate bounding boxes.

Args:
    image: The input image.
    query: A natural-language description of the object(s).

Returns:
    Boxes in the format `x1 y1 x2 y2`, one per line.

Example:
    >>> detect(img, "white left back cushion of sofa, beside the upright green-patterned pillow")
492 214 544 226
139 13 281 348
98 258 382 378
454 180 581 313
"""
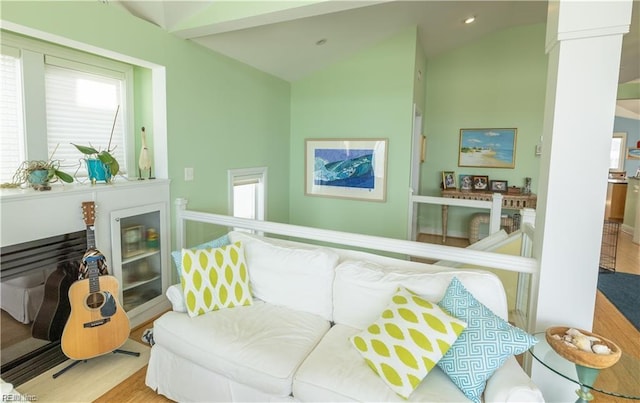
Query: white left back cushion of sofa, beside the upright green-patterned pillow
229 231 338 320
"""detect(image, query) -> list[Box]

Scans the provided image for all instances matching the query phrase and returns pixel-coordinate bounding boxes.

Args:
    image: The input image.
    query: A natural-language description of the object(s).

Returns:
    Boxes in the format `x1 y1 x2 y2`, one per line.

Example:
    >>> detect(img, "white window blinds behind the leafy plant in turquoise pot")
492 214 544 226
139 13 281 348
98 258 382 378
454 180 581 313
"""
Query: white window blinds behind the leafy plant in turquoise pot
45 56 126 176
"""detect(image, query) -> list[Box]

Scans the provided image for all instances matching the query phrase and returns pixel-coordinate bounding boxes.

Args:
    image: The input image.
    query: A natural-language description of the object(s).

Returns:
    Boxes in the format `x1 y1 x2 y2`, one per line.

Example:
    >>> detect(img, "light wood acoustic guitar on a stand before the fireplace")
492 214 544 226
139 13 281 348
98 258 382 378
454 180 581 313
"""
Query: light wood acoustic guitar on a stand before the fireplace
61 205 130 360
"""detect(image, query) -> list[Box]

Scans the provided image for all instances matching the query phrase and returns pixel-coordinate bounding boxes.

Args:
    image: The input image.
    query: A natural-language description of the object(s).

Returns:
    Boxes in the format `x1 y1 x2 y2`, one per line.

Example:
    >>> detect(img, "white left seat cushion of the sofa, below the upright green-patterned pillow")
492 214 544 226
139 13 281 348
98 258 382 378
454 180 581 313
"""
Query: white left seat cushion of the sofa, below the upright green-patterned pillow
153 301 329 397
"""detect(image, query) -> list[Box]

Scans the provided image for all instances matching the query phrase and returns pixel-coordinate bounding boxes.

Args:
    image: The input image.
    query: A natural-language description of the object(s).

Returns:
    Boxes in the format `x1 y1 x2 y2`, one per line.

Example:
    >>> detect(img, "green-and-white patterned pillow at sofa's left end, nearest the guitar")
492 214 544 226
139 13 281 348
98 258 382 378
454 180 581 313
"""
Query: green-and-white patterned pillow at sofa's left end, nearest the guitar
180 242 253 317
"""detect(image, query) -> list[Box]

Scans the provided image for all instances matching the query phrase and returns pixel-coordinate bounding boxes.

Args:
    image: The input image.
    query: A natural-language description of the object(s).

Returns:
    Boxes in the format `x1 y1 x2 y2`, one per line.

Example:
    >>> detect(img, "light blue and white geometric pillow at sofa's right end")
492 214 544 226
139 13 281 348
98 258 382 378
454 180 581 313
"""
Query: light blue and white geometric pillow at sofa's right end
438 277 537 403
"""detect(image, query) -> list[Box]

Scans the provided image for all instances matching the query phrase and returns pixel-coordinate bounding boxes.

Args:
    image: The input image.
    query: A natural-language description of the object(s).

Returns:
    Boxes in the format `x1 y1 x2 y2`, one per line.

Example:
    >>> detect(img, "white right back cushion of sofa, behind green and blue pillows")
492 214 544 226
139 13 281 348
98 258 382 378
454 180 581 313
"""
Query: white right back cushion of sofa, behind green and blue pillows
333 260 507 329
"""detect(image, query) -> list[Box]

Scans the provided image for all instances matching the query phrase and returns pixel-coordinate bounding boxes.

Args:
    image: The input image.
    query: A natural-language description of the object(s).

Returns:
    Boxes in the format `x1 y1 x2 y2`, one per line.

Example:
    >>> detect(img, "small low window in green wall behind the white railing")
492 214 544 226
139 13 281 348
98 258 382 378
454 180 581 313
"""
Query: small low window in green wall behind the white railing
229 167 267 220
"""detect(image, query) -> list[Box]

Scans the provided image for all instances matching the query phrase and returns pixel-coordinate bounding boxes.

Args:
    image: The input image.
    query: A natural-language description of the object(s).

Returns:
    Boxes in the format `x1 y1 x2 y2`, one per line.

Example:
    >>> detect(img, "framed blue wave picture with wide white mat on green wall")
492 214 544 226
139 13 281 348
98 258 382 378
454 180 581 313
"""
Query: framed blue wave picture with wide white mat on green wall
305 138 388 202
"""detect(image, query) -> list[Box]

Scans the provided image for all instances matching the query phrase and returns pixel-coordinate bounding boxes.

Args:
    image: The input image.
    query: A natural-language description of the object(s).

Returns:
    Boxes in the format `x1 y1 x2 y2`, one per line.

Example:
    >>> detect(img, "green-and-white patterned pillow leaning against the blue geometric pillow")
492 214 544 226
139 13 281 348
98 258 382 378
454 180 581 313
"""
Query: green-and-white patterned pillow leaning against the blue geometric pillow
349 287 467 399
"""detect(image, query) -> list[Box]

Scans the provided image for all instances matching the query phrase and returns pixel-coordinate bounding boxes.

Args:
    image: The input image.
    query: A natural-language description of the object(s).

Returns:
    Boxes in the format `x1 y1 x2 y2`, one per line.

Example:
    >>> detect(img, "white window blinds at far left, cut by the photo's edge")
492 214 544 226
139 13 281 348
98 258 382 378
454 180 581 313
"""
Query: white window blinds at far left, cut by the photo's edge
0 46 25 183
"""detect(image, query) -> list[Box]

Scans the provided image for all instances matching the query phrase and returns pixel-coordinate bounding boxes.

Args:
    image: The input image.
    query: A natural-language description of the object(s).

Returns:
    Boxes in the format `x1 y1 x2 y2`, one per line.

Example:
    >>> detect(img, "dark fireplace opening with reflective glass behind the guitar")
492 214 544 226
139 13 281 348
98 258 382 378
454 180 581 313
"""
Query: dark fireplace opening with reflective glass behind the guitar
0 231 87 386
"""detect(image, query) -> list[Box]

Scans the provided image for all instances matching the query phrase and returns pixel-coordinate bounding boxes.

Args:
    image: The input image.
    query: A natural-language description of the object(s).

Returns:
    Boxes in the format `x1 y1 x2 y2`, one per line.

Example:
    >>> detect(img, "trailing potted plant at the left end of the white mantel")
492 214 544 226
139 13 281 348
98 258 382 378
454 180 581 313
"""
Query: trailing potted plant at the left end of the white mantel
3 146 73 190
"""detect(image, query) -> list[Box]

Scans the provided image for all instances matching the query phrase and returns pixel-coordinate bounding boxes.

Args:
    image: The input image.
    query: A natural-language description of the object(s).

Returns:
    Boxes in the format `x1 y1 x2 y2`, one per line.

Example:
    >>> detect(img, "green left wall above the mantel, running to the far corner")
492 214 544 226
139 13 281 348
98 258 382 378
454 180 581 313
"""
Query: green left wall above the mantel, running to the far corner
1 1 290 246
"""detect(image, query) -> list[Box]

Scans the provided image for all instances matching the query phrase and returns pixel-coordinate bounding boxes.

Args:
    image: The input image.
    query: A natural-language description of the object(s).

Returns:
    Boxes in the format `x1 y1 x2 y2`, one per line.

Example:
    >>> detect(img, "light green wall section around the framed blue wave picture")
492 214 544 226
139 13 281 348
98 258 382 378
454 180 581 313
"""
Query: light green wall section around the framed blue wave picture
289 27 416 238
